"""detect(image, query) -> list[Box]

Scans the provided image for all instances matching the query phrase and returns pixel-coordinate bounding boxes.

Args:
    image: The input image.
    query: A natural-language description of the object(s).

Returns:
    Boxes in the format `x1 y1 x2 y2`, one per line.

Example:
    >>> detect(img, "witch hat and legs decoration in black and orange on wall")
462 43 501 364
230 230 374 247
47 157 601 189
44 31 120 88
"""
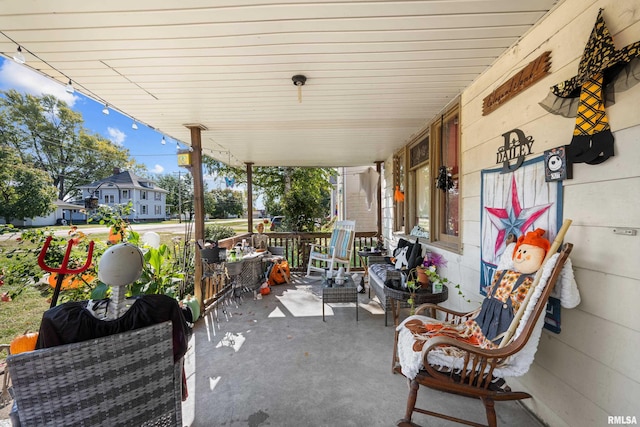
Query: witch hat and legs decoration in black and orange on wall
540 9 640 165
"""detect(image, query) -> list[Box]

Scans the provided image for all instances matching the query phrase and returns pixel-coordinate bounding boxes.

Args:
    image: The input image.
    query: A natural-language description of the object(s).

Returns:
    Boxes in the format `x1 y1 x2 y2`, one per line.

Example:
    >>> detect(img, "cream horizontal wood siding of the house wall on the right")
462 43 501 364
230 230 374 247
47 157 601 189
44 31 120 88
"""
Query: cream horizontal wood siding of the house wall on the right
383 0 640 426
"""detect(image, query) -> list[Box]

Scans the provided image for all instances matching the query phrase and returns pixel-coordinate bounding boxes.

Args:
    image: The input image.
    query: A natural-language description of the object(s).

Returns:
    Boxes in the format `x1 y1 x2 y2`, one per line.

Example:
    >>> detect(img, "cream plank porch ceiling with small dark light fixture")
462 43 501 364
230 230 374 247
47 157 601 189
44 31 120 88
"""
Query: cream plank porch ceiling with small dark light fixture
0 0 556 166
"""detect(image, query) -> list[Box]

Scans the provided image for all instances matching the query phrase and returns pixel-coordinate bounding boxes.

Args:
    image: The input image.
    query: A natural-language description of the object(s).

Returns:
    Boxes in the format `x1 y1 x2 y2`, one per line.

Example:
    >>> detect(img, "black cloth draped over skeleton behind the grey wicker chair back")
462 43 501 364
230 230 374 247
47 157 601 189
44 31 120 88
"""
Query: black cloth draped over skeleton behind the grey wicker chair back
36 295 190 361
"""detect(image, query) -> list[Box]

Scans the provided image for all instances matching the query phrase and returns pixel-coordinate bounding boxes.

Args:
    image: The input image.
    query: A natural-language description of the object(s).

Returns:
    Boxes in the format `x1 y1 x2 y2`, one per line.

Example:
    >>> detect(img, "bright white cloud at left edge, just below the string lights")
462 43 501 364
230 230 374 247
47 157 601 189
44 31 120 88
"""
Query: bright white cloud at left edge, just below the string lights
0 59 78 107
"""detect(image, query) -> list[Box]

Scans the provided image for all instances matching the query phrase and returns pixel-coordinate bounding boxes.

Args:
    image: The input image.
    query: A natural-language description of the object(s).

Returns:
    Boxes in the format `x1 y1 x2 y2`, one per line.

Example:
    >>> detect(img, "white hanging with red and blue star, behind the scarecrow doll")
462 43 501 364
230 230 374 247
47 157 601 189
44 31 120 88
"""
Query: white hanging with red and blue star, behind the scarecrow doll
480 157 562 294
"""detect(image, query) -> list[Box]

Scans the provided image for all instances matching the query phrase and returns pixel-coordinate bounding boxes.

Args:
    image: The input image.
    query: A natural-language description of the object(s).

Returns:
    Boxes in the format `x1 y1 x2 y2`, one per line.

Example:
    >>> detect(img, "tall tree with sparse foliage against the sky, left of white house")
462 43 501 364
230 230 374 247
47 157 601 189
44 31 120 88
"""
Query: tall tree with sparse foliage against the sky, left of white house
0 90 141 200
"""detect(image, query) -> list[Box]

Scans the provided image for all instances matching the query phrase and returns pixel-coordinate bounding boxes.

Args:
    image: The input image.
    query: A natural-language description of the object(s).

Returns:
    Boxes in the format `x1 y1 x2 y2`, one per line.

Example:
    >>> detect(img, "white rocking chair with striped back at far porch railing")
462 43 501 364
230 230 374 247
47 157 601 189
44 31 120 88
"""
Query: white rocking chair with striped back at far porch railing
307 221 356 277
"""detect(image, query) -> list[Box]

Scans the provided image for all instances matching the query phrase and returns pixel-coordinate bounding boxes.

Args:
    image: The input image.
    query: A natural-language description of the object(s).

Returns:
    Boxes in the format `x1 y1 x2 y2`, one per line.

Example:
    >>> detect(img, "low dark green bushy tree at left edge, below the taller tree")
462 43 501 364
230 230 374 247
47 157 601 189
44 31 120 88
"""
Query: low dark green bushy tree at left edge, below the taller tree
0 146 56 224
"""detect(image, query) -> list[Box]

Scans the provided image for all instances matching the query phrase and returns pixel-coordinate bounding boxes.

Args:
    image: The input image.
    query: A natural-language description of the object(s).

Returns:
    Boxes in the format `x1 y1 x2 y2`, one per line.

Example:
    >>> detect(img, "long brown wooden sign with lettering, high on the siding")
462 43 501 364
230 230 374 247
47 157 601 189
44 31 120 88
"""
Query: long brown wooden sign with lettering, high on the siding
482 51 551 116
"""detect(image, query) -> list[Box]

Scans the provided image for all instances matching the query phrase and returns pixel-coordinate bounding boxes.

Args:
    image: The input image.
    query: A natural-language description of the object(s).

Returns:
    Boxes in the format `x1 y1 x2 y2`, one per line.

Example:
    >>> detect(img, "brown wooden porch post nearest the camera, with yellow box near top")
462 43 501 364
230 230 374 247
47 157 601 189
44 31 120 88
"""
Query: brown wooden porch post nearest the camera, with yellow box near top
185 124 207 312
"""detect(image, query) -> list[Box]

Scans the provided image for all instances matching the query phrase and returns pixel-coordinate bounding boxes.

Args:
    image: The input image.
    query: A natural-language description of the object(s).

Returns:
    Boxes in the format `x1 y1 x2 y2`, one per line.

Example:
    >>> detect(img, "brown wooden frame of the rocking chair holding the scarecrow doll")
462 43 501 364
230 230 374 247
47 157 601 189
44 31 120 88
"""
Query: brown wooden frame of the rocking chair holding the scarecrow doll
394 243 573 427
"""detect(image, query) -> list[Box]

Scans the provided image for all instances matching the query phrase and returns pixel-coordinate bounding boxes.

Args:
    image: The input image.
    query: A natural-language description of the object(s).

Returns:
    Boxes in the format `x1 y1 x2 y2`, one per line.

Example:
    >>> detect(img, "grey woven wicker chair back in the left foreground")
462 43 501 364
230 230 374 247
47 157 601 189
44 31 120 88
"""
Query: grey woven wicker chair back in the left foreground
7 322 182 427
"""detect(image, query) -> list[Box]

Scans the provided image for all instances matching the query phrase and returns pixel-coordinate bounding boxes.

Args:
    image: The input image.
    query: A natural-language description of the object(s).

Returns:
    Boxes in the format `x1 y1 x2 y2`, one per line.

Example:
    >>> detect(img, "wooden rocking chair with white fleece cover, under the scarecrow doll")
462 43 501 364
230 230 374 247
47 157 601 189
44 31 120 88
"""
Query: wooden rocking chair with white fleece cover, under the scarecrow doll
394 243 572 427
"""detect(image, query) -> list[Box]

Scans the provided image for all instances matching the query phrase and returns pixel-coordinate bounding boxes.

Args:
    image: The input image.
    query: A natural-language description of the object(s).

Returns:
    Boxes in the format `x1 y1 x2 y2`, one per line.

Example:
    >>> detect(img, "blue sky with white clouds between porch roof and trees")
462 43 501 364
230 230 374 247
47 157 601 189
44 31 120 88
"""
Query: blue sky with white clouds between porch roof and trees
0 56 191 179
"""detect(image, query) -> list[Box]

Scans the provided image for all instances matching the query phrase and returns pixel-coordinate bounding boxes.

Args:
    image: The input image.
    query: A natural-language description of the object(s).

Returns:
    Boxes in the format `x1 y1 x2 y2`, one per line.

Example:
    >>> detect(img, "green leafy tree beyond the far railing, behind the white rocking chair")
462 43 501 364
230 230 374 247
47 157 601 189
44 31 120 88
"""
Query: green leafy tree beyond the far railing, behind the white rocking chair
203 156 335 231
